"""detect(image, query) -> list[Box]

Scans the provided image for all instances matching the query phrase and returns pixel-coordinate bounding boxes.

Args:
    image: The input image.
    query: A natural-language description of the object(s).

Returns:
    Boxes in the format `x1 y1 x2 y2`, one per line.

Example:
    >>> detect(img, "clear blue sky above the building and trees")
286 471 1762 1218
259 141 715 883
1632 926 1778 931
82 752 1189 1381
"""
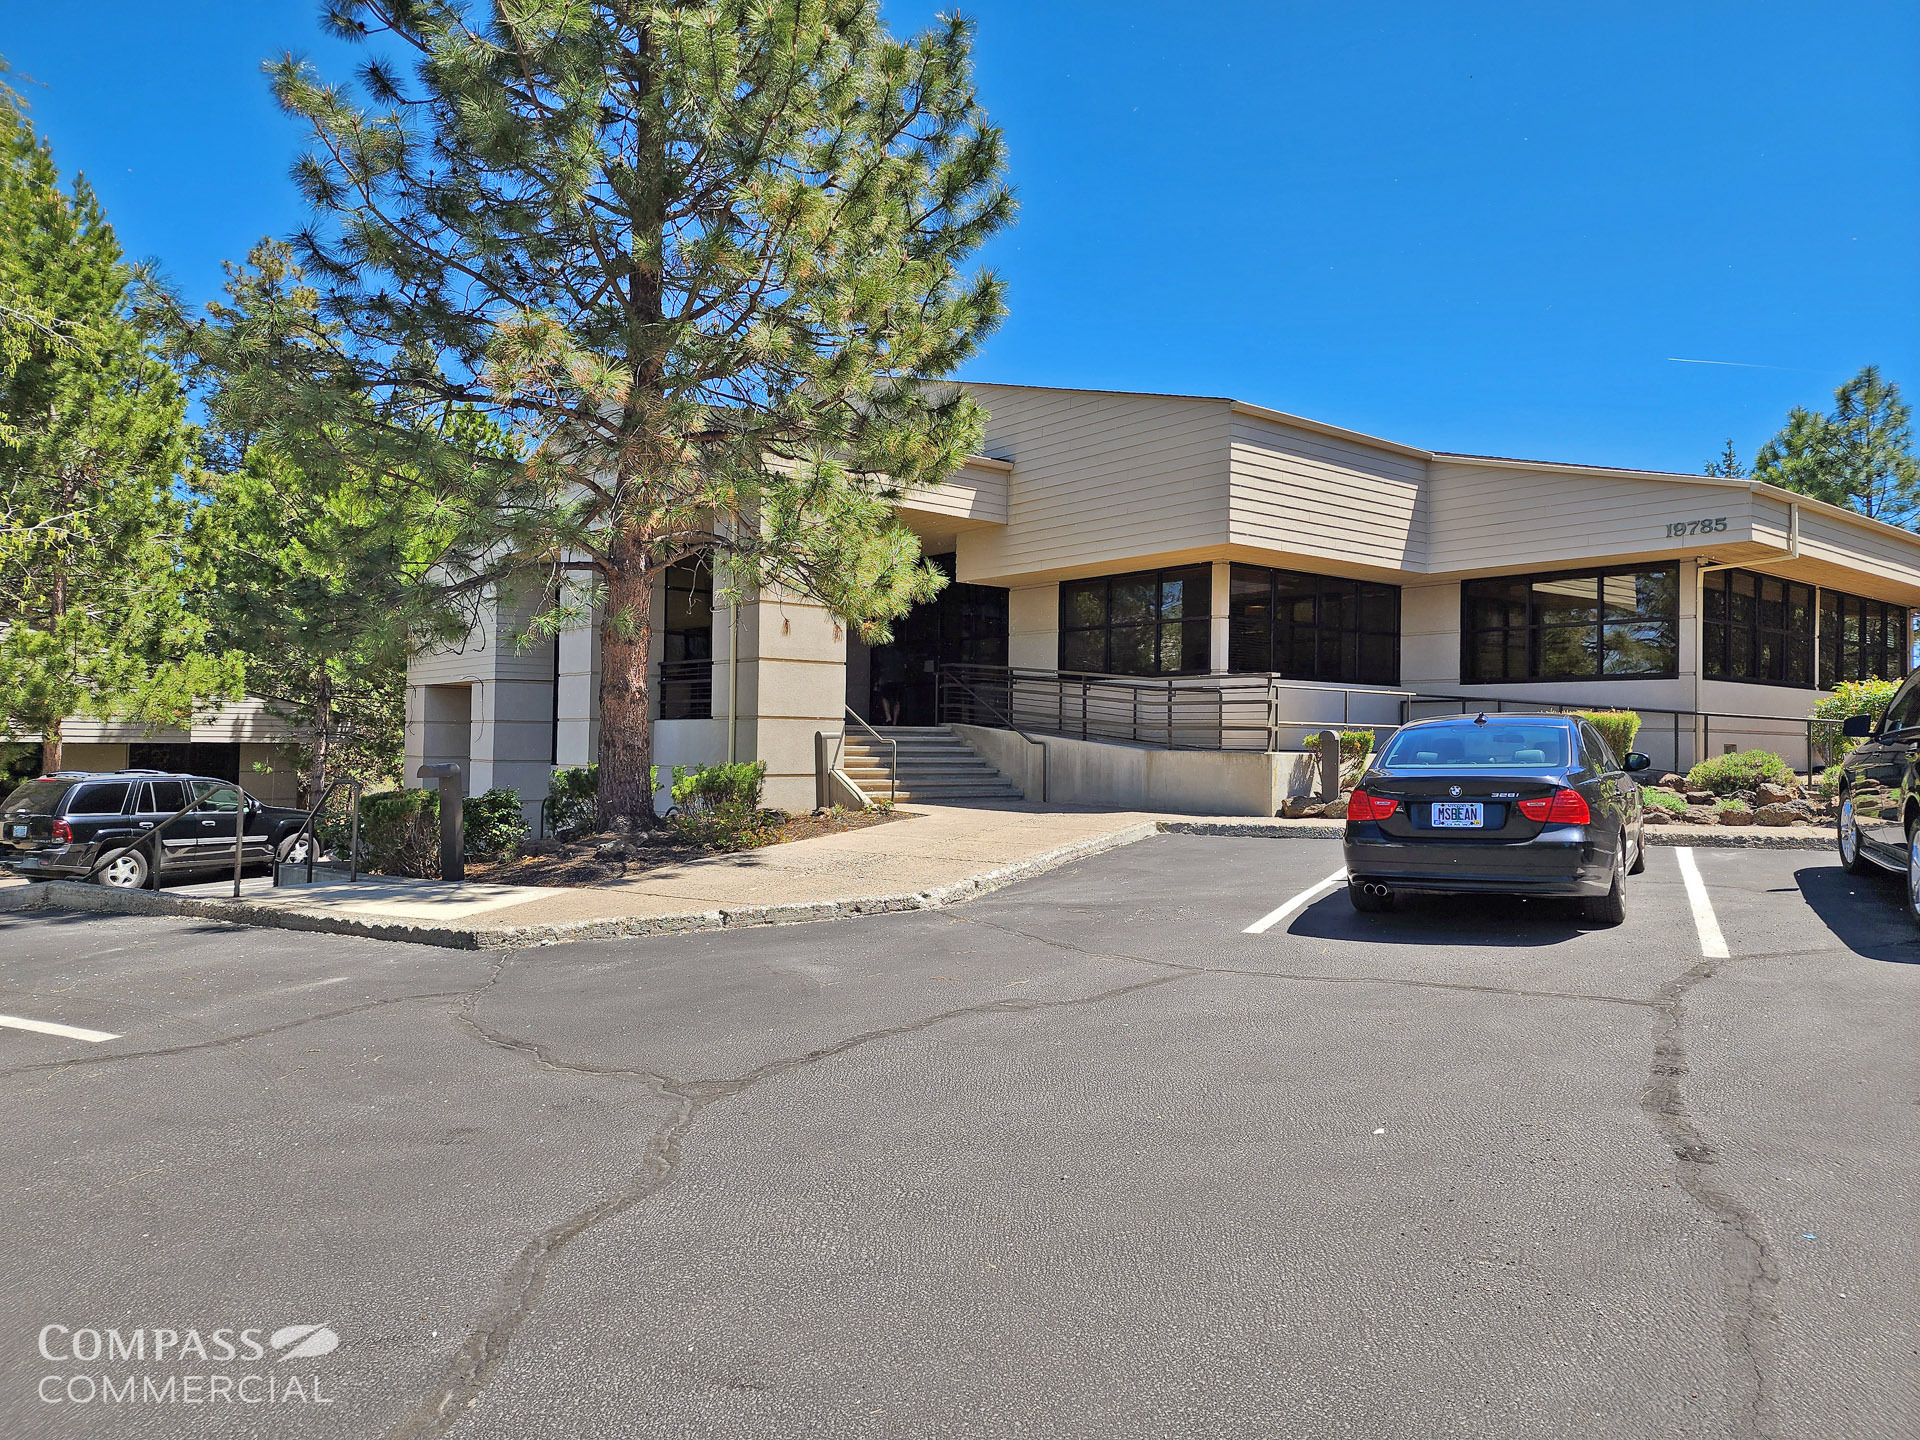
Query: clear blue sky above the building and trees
0 0 1920 470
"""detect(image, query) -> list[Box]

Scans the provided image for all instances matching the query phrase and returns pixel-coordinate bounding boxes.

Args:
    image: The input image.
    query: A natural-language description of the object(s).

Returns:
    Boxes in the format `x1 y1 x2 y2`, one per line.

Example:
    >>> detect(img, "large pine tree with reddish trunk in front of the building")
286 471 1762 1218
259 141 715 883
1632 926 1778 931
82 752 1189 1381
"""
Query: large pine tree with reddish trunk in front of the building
223 0 1014 822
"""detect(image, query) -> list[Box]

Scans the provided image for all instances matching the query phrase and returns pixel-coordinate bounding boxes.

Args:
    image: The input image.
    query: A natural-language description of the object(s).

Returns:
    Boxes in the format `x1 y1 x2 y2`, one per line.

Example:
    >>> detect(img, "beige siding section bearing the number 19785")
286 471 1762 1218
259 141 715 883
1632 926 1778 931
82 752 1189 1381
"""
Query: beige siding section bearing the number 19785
1428 461 1753 570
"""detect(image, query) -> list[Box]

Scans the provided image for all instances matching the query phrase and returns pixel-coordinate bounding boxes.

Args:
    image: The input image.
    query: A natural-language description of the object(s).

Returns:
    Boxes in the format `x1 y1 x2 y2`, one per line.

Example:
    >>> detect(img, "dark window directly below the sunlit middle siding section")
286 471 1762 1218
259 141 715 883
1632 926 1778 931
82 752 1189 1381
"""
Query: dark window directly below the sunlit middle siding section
1227 564 1400 685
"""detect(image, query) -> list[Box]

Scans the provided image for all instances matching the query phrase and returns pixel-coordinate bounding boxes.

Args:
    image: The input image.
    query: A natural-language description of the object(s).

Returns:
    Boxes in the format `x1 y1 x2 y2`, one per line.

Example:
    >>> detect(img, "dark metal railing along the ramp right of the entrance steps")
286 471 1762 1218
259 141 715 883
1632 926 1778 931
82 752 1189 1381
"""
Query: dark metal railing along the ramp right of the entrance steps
939 664 1413 753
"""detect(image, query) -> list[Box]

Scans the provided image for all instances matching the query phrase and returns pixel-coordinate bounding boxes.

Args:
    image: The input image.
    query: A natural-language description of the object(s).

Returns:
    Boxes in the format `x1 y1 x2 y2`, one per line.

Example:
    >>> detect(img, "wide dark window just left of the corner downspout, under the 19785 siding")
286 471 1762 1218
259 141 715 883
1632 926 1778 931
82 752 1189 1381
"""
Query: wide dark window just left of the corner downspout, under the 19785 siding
1461 564 1680 682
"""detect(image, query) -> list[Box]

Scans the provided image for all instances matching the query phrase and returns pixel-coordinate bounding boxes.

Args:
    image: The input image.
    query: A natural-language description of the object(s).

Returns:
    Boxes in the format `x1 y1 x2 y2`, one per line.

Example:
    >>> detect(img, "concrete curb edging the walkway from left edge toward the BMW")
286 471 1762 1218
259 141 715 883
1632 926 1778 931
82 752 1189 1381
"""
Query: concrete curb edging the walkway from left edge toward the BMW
0 822 1158 950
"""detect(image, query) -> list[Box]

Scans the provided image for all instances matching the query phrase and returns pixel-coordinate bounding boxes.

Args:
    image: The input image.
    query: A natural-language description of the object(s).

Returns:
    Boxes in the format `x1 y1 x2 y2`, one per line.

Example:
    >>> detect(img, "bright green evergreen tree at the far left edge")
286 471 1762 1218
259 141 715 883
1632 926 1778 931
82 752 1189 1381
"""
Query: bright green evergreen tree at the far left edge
0 73 240 770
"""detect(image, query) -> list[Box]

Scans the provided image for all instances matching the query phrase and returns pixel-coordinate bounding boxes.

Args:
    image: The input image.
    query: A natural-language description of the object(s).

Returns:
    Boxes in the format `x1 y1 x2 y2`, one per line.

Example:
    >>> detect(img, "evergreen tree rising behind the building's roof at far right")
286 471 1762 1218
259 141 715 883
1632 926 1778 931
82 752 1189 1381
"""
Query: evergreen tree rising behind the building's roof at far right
1753 365 1920 530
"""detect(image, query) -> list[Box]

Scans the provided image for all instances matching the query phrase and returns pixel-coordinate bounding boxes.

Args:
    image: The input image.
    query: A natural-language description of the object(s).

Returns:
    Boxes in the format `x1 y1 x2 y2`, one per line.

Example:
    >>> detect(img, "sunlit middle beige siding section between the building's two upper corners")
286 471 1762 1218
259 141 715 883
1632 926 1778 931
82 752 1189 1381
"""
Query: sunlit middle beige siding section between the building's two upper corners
1231 415 1427 568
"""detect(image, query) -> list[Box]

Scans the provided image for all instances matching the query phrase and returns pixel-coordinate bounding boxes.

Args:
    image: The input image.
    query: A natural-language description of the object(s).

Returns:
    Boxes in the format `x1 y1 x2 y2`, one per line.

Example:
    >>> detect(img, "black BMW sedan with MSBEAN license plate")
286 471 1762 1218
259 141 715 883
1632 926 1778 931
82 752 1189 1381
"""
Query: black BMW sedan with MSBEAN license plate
1346 714 1649 925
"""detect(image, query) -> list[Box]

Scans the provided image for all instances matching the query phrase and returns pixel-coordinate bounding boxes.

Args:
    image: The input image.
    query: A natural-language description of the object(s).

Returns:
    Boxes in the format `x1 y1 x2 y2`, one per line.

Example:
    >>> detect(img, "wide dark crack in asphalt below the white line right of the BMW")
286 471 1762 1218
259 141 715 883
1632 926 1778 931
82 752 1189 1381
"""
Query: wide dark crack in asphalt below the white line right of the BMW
1640 960 1780 1440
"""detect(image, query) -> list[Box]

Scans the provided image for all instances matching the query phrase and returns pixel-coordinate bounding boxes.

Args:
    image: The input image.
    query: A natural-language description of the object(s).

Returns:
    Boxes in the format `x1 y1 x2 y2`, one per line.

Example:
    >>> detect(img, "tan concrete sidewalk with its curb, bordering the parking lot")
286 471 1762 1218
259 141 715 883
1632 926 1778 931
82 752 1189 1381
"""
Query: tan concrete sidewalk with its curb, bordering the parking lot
0 803 1832 948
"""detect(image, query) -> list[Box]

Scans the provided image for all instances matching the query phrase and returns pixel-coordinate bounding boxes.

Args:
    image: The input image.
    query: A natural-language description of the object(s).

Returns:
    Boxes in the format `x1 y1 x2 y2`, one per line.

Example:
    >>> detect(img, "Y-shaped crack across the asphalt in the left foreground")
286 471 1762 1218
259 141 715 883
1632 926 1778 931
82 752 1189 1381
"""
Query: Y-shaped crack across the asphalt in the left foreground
384 973 1183 1440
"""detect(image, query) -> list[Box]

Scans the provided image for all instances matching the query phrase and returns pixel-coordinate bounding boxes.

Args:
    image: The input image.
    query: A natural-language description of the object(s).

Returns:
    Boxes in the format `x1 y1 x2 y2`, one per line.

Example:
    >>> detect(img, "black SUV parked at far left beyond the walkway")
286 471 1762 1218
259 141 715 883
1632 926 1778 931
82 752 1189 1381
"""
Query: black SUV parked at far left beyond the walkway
0 770 307 889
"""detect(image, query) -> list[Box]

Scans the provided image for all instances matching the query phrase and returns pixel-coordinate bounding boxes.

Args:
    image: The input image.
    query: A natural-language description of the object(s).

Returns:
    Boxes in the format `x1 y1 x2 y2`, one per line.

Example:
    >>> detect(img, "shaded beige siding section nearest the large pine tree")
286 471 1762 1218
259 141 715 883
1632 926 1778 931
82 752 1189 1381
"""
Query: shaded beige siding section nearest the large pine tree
960 386 1229 584
